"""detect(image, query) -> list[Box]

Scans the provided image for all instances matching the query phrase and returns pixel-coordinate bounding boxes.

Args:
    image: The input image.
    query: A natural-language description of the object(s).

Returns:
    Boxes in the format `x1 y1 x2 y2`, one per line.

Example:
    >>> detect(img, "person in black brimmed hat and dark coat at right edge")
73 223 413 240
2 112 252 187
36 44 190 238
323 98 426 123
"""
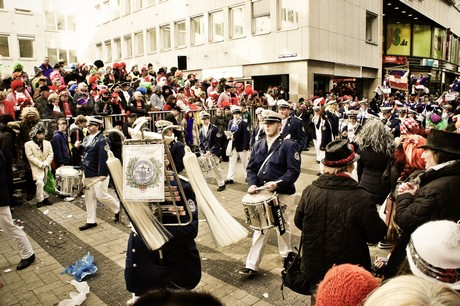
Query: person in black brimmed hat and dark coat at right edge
385 129 460 278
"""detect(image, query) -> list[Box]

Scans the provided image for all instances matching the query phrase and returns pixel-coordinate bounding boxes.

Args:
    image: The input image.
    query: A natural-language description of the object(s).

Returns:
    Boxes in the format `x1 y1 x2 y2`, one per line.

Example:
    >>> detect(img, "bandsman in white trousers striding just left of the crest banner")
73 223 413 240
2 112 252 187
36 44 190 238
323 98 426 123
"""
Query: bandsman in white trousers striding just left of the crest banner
78 117 120 231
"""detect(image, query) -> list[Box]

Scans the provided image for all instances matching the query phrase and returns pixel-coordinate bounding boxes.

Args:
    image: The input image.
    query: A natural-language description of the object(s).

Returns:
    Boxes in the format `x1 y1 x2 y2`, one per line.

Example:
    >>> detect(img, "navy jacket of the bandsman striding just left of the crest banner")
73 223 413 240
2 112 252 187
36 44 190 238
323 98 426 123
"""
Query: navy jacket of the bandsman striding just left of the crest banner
83 132 109 178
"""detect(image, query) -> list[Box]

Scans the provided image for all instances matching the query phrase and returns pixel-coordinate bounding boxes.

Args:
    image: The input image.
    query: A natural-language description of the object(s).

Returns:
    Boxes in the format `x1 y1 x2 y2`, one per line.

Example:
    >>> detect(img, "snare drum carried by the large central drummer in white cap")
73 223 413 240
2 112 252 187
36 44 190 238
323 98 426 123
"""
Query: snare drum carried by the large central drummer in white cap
242 190 279 230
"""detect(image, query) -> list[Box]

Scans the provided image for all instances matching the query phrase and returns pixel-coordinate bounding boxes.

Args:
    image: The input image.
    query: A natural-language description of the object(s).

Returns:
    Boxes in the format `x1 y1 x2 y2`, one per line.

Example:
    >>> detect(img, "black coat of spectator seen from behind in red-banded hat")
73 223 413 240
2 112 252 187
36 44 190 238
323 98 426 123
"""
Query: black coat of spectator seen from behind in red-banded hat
294 174 387 289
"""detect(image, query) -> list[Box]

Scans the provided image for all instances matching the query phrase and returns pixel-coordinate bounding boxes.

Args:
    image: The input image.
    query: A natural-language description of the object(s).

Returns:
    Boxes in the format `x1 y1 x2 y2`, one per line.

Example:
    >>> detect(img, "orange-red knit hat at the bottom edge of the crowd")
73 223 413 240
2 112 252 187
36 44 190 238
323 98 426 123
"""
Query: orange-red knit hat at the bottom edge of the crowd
315 264 380 306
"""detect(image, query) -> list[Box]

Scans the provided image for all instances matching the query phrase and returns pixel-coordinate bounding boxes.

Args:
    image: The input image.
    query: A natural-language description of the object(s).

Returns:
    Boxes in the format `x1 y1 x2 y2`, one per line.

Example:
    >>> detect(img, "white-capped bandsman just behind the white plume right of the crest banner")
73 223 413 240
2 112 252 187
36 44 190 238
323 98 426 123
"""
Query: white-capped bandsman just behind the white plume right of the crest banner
198 111 225 191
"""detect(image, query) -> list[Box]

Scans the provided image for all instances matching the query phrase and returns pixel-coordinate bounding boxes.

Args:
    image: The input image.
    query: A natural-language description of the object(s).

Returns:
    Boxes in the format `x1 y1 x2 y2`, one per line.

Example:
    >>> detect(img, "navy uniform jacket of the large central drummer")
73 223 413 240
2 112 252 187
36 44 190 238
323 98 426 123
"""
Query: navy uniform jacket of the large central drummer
247 136 300 194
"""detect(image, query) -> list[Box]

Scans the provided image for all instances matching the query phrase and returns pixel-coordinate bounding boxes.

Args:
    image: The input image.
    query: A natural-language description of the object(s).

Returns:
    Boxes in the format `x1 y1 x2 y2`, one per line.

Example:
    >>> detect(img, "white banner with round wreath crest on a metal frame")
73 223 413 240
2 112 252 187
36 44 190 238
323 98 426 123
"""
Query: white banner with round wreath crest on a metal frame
123 144 165 202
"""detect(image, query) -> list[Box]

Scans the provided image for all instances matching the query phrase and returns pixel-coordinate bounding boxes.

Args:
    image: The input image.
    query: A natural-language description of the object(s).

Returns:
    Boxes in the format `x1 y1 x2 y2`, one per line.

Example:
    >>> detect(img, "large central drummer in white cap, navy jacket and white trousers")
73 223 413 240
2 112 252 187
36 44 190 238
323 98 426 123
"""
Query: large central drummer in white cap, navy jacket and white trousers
240 110 300 275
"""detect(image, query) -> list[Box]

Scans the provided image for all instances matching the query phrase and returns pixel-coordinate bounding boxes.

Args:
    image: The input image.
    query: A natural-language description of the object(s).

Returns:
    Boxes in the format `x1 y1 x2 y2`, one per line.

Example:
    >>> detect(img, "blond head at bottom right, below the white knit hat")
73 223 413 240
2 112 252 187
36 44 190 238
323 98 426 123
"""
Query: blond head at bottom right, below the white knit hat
364 275 460 306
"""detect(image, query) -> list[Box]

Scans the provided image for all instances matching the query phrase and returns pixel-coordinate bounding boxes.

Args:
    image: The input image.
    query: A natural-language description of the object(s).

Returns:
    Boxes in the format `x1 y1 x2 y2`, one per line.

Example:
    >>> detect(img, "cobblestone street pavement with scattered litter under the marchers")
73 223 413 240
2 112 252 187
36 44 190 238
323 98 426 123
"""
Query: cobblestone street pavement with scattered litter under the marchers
0 151 387 306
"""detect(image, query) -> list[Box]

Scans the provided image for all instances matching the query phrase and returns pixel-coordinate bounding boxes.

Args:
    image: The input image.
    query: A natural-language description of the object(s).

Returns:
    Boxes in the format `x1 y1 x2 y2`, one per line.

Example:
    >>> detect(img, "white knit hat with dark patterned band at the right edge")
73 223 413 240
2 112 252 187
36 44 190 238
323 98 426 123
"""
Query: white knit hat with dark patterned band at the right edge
406 220 460 290
